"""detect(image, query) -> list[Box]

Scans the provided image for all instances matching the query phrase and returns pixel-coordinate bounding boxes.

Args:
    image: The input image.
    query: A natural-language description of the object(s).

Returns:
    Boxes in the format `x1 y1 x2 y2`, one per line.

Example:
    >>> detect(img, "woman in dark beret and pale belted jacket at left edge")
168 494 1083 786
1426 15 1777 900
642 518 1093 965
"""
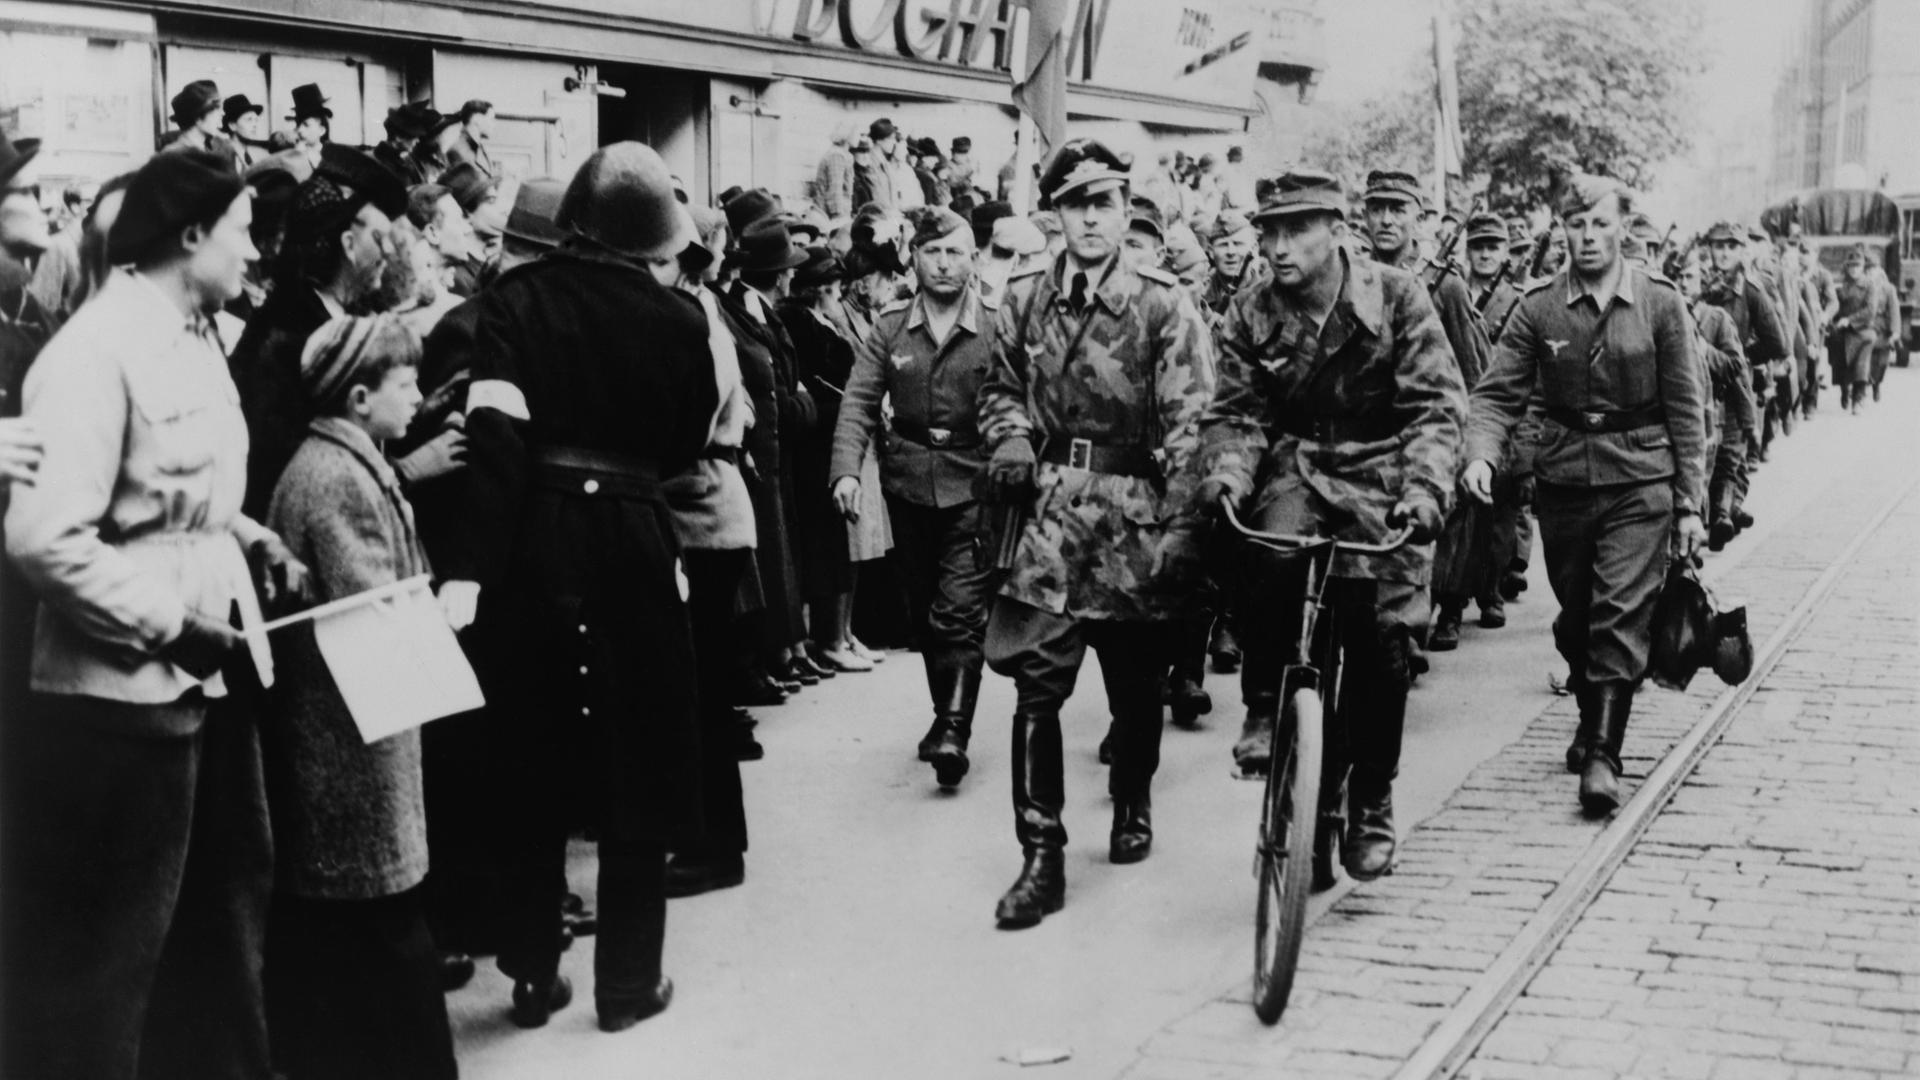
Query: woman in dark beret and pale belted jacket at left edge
0 150 305 1080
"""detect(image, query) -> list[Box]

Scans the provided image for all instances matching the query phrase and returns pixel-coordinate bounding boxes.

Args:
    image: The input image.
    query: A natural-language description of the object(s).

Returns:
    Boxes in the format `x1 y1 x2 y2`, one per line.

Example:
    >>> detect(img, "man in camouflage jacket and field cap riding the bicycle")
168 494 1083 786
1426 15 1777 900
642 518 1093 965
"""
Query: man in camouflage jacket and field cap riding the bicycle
1200 171 1467 880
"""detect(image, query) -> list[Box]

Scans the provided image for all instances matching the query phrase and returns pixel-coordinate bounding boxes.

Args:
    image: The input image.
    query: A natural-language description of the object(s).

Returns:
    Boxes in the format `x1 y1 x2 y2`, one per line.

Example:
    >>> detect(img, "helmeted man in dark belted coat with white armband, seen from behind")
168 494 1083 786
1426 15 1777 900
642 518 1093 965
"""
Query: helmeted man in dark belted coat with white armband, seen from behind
442 142 718 1030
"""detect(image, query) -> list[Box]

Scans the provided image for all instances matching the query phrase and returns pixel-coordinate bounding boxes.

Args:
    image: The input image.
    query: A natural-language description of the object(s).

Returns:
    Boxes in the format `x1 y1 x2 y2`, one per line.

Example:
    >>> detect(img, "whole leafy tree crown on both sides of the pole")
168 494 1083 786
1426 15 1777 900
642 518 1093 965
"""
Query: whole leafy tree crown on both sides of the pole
1302 0 1705 211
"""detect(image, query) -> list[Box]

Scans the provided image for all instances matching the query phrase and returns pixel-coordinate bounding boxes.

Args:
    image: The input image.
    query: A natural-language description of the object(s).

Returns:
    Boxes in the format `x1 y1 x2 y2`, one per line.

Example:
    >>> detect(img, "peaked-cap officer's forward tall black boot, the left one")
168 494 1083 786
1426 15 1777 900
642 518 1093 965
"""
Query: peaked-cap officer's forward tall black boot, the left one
995 703 1075 930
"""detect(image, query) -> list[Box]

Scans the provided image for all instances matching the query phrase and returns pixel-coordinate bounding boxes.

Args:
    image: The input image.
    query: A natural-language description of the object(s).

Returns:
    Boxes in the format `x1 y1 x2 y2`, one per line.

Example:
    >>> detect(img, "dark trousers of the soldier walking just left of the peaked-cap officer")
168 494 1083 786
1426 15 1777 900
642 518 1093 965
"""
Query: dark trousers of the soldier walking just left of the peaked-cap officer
887 496 998 676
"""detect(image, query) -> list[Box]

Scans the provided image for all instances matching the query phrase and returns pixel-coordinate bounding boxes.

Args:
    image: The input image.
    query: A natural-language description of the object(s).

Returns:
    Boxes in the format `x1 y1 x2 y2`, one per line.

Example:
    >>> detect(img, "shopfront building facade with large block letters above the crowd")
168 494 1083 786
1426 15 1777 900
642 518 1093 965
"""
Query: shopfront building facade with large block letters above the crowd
0 0 1321 211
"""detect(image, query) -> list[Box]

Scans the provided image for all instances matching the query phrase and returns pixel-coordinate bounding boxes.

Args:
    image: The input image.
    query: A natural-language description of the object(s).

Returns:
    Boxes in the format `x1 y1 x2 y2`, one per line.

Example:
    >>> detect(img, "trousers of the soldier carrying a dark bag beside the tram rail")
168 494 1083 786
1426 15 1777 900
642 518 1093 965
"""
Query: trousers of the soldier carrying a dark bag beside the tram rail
1536 480 1674 686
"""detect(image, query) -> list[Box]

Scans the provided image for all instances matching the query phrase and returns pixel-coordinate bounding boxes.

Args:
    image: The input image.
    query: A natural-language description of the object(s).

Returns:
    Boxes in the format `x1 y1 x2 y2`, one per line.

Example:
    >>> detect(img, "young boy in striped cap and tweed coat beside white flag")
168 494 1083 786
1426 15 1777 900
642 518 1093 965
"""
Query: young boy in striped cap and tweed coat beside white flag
263 307 455 1080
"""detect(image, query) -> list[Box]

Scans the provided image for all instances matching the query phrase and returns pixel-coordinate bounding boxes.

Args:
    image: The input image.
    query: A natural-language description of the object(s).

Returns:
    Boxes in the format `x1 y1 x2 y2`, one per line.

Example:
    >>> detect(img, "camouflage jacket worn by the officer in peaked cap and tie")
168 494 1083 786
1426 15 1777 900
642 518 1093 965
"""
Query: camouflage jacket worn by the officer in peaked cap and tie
979 256 1213 621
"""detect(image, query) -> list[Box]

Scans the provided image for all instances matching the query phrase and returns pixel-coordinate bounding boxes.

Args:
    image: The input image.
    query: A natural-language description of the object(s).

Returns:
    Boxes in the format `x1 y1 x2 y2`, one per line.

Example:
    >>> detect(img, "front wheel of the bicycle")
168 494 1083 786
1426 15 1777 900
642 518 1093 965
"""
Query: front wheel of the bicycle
1254 688 1323 1024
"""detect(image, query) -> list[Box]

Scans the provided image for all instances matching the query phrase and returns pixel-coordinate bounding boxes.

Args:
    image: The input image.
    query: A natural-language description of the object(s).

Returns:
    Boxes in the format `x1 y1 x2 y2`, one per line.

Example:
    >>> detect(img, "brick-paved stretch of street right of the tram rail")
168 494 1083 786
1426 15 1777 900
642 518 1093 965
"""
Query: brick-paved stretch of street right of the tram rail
1465 498 1920 1080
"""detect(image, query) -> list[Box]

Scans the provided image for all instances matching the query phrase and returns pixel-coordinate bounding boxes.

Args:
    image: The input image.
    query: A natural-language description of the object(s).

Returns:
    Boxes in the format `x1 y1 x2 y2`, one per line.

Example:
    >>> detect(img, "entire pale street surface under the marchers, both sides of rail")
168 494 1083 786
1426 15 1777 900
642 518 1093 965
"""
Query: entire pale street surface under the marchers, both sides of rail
451 373 1920 1080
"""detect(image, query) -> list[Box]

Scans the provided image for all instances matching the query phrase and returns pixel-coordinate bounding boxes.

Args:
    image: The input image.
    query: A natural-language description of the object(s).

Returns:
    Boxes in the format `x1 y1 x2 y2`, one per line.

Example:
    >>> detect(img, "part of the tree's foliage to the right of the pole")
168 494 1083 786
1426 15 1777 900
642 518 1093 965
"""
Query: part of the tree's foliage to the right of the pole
1459 0 1707 206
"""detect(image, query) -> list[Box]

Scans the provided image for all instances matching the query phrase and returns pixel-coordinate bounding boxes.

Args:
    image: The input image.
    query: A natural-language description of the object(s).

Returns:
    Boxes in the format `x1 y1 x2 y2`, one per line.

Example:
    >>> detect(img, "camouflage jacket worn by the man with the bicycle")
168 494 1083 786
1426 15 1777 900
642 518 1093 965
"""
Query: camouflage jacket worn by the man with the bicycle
1200 254 1467 584
